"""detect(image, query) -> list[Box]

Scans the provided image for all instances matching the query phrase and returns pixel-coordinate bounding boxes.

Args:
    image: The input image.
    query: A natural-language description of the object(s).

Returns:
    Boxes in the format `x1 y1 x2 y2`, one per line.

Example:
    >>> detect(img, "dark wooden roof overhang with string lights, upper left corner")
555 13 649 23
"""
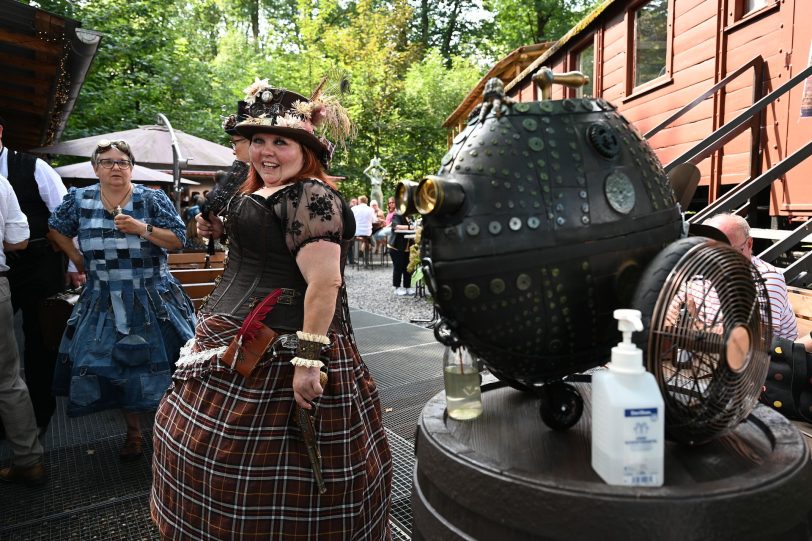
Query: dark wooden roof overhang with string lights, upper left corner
0 0 101 150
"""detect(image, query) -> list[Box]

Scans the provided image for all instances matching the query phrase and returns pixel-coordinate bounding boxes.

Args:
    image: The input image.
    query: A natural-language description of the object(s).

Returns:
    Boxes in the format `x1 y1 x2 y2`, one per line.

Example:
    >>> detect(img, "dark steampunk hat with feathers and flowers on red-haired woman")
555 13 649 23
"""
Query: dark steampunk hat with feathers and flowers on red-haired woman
235 76 355 166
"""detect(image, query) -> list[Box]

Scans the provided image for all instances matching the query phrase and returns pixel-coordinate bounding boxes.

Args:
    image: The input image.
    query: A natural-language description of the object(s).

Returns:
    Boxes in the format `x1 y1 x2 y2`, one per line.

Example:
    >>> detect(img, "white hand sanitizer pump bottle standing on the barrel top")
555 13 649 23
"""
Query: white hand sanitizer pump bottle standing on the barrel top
592 310 665 486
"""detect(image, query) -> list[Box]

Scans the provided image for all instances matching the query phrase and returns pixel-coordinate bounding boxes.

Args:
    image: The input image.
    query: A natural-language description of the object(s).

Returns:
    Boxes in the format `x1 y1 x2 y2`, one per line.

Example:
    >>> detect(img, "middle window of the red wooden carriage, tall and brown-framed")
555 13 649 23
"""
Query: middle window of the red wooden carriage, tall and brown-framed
634 0 668 86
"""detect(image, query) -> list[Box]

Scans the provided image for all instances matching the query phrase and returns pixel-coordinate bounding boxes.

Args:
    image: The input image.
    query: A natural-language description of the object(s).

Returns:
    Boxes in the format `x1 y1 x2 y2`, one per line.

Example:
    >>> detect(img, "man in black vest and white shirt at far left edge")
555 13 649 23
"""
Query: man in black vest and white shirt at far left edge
0 118 79 431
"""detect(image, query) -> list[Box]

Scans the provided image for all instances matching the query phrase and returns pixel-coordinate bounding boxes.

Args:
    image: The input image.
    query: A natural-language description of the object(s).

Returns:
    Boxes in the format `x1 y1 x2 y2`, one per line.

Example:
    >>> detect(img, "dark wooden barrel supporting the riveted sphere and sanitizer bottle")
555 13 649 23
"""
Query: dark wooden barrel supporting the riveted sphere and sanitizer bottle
412 383 812 541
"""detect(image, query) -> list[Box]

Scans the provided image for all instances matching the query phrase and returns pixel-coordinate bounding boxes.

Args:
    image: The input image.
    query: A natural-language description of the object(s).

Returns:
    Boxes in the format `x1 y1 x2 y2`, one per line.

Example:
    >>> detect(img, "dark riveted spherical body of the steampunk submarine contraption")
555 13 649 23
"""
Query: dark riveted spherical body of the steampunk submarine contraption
417 98 682 385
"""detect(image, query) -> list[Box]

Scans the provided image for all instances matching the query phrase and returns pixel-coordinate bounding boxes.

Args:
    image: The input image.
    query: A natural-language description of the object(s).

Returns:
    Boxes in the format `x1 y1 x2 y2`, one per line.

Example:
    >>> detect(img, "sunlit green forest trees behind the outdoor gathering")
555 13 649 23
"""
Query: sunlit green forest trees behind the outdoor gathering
23 0 598 195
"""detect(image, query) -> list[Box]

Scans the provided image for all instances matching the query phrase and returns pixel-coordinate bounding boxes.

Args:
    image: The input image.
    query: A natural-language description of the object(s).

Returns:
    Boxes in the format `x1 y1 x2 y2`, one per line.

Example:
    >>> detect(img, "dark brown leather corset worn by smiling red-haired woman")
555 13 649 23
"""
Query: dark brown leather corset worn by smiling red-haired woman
200 196 316 330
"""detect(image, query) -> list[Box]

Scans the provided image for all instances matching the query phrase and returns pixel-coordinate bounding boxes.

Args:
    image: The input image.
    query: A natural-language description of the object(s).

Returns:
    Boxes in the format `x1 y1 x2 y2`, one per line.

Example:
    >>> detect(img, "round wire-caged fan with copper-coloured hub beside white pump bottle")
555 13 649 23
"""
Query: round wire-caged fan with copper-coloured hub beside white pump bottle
633 237 771 444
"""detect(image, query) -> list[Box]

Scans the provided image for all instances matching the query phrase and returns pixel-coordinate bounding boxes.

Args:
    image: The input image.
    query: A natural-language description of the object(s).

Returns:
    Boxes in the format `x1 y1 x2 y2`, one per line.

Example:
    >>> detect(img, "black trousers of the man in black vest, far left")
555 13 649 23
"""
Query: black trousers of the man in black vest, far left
6 240 66 428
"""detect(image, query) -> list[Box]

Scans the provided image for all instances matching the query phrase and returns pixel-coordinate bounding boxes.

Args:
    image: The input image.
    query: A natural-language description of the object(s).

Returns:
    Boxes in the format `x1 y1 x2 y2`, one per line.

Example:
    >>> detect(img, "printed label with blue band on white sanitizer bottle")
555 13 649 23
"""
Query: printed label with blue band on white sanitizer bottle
623 408 660 486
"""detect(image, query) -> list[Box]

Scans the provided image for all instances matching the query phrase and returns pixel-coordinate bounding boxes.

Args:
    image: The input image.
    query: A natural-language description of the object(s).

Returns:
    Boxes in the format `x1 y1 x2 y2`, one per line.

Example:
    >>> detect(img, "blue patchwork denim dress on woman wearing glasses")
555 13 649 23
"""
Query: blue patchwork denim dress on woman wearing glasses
48 184 195 416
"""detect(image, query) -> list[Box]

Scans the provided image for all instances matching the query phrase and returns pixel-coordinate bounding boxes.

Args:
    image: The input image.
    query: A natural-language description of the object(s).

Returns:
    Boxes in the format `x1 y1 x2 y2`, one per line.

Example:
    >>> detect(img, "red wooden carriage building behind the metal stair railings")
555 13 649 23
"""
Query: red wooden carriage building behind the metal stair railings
446 0 812 219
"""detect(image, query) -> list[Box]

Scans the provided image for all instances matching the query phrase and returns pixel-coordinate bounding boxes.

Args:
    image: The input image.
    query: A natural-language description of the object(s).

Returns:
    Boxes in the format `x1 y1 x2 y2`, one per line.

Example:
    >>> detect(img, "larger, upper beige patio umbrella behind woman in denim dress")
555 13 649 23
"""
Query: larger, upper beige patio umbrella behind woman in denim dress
31 125 234 171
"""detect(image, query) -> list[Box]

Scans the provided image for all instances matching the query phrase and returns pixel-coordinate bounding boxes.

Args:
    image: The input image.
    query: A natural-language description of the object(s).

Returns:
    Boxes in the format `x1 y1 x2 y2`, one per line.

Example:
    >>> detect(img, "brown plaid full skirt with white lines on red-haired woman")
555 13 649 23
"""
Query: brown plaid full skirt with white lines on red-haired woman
150 316 392 541
